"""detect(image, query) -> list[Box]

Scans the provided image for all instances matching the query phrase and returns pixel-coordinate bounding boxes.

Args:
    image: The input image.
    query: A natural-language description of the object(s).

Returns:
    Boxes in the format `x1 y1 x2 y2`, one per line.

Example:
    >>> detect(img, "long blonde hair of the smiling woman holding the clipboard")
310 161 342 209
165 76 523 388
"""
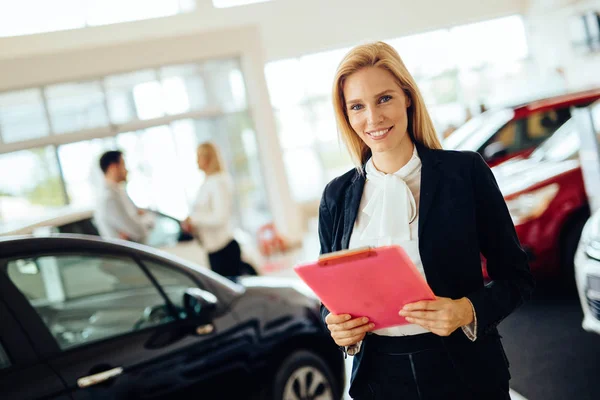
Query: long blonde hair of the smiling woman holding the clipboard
333 42 442 171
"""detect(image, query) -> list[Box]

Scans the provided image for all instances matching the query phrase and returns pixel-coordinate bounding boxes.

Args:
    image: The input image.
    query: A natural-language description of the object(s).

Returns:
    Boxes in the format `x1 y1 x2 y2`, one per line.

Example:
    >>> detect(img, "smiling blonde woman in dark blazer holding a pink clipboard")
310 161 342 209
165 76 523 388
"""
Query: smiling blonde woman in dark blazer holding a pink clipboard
319 42 534 400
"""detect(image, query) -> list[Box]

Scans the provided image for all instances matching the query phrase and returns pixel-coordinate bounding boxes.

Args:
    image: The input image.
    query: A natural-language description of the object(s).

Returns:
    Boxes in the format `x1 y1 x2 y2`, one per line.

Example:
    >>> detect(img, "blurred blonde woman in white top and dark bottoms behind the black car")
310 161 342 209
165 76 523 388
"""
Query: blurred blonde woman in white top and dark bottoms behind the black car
183 142 243 277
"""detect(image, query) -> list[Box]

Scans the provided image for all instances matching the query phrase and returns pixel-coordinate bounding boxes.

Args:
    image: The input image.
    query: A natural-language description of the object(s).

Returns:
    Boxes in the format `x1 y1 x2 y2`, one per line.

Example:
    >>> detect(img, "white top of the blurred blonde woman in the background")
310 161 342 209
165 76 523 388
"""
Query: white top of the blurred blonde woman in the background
190 172 233 253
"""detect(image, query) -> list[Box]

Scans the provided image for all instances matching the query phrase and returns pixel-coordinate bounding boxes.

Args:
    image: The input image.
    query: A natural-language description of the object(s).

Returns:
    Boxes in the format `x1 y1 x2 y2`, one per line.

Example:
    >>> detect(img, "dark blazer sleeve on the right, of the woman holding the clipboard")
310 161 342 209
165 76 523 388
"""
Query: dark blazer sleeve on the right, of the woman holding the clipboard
467 153 535 337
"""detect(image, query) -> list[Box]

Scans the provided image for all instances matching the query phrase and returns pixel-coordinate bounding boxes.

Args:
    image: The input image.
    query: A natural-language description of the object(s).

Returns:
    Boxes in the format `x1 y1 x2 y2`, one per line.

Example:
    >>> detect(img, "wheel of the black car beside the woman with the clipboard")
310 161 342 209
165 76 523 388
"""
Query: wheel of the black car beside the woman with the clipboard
268 350 340 400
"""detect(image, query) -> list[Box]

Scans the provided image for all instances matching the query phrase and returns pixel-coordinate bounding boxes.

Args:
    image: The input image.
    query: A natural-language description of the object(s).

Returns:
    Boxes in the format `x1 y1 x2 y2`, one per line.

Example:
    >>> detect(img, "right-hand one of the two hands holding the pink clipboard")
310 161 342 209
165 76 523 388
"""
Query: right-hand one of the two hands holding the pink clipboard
400 296 474 336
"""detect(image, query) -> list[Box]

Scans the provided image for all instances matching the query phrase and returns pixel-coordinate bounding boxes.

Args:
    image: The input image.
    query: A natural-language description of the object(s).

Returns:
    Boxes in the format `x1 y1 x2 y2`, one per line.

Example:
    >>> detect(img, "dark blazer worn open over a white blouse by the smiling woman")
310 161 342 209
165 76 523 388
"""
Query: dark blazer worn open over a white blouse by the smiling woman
319 142 534 394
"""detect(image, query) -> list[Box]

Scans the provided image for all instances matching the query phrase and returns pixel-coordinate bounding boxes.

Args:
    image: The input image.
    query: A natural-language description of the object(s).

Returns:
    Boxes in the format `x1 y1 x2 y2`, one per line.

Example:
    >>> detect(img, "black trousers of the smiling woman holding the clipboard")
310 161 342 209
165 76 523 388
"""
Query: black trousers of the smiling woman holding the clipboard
350 333 510 400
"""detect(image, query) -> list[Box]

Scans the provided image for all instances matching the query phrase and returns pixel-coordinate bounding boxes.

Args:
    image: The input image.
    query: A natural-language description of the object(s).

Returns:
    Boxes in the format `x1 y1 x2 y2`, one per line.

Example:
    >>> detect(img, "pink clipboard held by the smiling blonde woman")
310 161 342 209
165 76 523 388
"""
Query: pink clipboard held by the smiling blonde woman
294 246 435 329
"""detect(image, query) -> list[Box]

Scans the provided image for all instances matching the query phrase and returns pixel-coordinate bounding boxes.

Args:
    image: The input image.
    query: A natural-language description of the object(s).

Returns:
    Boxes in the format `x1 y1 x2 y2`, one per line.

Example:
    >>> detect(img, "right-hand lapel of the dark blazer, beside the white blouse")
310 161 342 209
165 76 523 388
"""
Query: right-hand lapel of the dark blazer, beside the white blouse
415 142 440 240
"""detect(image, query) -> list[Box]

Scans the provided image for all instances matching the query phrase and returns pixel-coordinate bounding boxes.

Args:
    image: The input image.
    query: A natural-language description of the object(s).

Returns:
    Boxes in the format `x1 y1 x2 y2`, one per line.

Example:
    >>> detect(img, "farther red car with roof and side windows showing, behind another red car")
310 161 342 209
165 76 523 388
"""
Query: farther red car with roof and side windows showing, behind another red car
444 88 600 167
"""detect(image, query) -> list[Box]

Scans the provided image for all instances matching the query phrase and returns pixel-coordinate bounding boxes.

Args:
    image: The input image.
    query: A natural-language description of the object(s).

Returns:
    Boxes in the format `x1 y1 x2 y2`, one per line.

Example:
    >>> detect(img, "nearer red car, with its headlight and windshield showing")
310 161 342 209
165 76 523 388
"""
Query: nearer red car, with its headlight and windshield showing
492 119 590 281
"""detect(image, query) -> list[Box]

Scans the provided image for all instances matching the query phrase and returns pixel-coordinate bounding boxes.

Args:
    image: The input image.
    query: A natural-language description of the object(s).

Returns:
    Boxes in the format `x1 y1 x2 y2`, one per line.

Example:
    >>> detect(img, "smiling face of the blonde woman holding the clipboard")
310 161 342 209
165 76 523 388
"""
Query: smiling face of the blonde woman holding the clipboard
343 67 410 155
